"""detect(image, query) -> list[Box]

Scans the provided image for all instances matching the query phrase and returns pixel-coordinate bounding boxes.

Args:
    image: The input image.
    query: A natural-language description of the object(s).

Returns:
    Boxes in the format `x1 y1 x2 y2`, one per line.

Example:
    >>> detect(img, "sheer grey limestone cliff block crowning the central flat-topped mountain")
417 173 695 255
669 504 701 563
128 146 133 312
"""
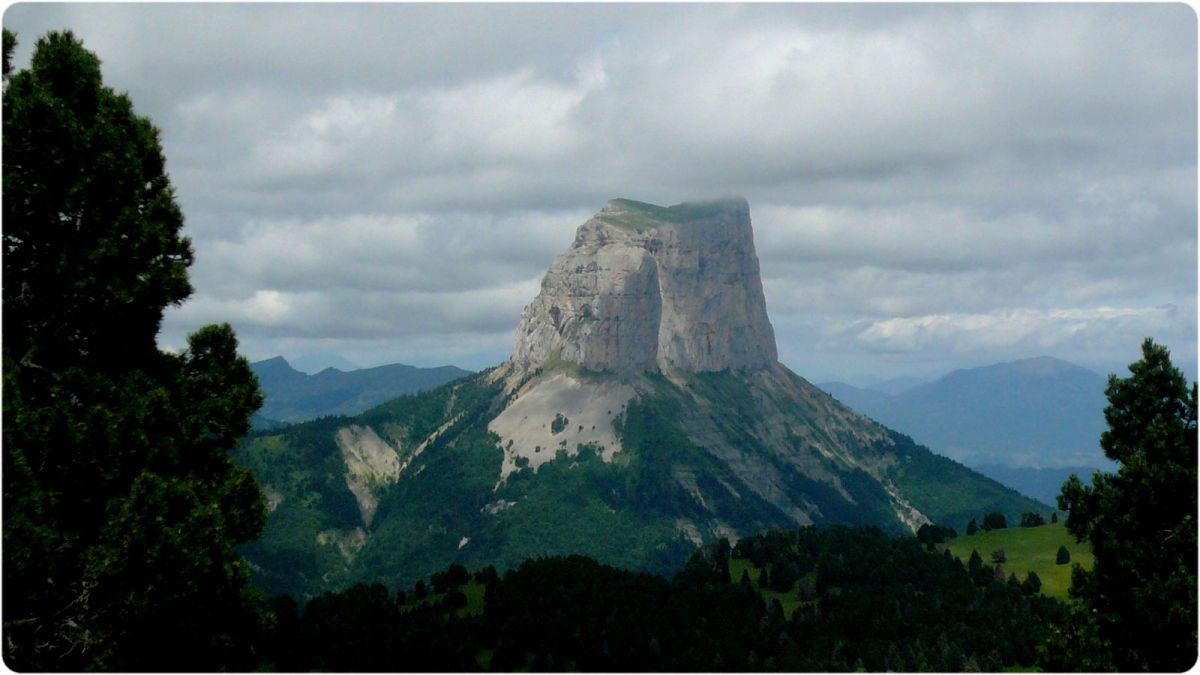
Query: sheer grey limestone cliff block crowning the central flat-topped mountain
512 198 778 372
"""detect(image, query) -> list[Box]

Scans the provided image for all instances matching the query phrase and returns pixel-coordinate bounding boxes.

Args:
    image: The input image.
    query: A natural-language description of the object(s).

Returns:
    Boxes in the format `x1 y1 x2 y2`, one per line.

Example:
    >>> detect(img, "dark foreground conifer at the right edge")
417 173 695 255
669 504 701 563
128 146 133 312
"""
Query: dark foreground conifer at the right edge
1045 339 1196 671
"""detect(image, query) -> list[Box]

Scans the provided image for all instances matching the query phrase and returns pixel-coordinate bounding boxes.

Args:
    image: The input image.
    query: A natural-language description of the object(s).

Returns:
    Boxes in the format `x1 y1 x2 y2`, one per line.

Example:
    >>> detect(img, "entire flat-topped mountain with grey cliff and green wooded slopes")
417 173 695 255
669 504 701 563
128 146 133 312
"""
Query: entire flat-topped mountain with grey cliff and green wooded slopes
238 198 1049 593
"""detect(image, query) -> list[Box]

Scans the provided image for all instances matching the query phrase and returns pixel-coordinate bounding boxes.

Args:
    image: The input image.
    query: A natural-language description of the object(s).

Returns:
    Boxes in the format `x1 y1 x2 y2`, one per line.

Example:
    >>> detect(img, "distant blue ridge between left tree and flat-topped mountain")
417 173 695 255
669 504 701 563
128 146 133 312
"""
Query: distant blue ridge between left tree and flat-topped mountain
250 357 470 429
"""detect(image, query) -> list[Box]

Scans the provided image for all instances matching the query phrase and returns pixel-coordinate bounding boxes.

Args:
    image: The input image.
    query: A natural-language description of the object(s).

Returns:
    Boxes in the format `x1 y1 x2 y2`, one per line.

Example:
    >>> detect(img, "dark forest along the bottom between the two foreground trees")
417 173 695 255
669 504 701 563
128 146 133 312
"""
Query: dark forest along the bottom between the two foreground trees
262 526 1066 671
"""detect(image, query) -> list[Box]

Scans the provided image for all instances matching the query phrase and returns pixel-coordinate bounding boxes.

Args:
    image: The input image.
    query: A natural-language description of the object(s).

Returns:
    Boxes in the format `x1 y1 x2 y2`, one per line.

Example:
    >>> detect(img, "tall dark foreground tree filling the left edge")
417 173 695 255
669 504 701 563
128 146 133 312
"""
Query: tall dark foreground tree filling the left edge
4 31 265 670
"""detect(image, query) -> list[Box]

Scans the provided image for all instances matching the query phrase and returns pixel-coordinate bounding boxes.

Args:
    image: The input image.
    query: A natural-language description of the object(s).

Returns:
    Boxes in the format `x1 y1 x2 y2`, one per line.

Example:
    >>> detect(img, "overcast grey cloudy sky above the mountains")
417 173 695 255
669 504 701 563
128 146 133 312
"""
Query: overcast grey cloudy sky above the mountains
4 4 1196 383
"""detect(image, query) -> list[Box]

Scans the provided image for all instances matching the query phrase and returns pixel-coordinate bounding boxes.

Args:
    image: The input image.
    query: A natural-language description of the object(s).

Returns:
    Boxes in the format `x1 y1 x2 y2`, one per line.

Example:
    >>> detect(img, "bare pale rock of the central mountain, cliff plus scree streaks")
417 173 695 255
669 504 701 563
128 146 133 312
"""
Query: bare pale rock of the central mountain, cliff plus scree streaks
488 197 902 504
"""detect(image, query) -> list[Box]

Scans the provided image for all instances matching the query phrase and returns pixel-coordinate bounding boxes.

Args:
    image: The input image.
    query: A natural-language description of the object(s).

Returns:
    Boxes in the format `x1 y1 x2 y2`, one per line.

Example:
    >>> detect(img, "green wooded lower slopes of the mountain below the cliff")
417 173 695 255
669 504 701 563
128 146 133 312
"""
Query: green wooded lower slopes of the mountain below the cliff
235 360 1049 597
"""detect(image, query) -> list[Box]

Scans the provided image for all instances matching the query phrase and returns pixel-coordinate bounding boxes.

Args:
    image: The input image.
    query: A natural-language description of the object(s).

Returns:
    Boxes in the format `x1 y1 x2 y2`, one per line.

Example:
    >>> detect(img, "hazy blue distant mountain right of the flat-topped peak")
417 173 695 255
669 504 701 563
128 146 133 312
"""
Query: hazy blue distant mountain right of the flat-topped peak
821 357 1109 470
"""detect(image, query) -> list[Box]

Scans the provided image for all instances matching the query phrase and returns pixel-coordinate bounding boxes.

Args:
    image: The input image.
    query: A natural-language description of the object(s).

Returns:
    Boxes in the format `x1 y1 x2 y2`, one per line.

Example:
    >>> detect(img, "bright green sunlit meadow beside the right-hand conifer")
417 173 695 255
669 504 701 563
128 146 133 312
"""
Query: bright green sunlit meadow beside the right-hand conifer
946 522 1093 601
